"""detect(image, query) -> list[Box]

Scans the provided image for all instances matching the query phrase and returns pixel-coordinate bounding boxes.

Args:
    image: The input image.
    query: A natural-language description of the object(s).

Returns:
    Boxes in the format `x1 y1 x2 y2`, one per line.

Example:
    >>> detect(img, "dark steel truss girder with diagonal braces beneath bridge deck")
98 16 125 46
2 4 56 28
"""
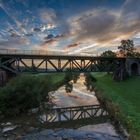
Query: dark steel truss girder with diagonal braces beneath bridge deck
0 56 125 74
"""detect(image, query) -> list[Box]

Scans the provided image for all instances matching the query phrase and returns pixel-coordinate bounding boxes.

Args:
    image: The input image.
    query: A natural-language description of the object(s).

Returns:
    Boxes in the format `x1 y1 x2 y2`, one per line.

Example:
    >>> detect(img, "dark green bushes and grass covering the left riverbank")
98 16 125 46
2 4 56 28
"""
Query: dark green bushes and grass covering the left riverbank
0 72 77 117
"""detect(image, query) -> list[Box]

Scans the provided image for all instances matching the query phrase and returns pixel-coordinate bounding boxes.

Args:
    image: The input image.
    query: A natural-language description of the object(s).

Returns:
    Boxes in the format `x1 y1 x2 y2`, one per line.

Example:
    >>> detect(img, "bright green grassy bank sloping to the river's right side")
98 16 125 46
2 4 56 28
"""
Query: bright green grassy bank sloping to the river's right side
92 73 140 139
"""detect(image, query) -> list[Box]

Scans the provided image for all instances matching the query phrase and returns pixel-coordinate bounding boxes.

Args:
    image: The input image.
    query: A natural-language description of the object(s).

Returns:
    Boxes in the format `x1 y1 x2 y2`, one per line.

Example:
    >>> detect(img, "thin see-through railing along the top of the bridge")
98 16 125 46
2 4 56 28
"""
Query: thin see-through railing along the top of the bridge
0 49 99 56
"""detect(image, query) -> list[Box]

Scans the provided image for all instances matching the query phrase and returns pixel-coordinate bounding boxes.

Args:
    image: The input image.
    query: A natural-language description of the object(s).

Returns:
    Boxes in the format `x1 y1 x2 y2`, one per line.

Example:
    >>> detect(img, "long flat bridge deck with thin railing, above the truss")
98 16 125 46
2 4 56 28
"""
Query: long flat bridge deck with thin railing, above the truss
0 49 125 60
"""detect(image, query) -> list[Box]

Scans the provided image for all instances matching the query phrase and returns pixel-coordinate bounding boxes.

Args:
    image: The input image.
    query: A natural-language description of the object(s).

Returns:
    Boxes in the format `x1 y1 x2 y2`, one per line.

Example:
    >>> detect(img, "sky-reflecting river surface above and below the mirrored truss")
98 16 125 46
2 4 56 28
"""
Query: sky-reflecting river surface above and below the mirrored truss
0 74 122 140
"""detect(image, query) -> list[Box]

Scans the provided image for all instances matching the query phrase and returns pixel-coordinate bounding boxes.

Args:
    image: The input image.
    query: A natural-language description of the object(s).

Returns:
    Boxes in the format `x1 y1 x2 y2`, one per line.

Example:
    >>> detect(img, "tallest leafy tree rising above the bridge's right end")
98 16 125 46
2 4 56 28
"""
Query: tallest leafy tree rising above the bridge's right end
118 39 135 57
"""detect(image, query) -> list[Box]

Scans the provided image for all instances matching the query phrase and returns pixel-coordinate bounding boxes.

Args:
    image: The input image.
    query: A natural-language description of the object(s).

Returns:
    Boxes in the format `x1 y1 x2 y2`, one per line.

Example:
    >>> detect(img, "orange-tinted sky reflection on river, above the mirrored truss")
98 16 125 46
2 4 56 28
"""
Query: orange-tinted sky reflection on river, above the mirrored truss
52 74 99 107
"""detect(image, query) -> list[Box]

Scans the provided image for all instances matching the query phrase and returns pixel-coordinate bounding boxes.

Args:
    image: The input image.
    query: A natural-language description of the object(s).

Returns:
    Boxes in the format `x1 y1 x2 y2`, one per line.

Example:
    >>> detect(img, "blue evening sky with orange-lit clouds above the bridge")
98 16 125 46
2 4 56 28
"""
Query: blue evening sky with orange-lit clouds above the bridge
0 0 140 54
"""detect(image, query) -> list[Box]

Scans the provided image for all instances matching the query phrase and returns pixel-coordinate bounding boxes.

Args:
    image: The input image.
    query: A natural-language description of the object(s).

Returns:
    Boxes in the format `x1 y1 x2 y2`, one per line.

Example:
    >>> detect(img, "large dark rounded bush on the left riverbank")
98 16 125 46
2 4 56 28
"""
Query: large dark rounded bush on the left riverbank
0 75 42 116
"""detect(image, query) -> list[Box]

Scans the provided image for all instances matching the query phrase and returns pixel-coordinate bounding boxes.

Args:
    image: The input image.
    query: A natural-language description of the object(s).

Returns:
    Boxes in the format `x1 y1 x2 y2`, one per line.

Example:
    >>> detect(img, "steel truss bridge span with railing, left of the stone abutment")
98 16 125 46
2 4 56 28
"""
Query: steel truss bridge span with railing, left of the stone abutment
0 50 125 74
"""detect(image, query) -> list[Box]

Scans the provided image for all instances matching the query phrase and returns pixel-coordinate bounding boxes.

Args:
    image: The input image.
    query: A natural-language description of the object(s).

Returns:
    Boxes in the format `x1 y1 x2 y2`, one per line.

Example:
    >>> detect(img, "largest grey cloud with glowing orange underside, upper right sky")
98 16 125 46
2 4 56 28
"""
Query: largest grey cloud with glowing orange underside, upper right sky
60 0 140 52
